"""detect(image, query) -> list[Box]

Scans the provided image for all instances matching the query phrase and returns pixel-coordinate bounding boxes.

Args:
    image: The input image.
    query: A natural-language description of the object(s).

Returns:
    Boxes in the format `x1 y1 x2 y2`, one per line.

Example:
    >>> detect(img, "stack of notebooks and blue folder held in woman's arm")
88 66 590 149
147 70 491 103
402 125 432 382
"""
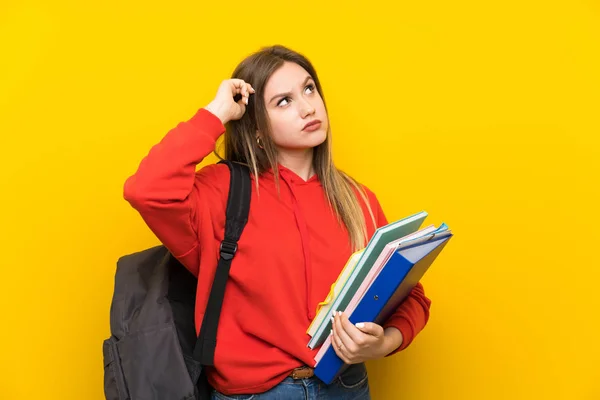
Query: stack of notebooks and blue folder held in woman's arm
307 211 452 384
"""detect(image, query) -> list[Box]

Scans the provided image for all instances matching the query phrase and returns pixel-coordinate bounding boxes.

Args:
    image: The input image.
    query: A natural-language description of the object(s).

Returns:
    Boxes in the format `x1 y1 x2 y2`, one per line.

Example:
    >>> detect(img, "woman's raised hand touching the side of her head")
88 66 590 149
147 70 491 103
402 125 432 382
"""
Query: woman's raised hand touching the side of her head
204 79 255 124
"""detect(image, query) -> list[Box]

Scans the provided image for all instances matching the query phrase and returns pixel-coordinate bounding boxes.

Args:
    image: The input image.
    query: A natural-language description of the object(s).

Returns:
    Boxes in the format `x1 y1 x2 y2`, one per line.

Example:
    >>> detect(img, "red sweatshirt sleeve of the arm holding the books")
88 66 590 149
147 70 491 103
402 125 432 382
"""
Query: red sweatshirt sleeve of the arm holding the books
371 192 431 356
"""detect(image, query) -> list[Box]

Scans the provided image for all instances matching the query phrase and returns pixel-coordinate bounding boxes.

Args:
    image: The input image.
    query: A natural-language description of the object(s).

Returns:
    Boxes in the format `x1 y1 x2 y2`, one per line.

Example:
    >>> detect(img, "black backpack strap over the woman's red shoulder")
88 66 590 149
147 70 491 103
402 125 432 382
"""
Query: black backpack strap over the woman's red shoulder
194 160 252 365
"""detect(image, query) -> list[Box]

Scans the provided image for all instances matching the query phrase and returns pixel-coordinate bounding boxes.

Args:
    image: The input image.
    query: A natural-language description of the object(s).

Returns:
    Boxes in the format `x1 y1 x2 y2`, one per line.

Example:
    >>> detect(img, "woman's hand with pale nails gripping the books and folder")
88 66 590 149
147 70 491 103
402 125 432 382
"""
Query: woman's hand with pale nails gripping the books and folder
331 312 389 364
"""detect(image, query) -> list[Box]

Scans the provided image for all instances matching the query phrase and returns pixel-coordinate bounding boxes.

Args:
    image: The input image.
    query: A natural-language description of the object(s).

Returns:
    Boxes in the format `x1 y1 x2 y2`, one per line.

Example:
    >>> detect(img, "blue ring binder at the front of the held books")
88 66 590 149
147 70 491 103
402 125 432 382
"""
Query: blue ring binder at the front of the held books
315 234 452 384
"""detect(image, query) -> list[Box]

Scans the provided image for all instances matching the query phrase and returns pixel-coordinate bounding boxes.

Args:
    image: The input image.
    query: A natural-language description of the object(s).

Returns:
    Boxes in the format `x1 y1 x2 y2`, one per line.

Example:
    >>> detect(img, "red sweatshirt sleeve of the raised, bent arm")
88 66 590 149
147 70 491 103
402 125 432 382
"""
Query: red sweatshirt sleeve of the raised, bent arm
123 108 225 276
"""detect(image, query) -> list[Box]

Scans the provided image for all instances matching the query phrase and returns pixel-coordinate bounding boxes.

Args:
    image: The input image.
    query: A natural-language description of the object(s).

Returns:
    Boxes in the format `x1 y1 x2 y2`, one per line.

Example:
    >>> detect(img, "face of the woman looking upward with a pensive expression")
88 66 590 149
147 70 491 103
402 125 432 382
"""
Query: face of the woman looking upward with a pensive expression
264 62 329 152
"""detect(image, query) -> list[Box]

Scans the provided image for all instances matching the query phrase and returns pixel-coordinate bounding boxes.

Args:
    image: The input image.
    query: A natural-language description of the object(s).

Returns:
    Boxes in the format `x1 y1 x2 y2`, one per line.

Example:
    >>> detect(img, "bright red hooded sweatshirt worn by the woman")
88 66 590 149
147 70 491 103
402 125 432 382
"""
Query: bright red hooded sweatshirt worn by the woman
124 109 430 394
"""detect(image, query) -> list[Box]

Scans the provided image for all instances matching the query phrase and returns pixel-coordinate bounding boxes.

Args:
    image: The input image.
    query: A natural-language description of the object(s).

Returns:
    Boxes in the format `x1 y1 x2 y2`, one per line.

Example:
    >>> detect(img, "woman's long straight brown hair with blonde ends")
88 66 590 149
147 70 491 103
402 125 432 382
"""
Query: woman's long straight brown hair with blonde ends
215 45 376 251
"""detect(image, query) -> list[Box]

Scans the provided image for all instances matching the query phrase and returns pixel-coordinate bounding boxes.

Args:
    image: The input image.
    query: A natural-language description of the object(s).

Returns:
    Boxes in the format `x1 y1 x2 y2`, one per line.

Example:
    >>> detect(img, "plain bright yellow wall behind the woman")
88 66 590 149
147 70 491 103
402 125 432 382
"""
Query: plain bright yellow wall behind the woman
0 0 600 400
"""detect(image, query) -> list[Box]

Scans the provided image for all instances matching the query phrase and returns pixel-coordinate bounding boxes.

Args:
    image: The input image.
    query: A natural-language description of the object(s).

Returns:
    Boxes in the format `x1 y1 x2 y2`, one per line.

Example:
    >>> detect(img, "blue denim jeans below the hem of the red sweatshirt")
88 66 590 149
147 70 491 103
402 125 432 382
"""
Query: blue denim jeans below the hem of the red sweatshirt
211 363 371 400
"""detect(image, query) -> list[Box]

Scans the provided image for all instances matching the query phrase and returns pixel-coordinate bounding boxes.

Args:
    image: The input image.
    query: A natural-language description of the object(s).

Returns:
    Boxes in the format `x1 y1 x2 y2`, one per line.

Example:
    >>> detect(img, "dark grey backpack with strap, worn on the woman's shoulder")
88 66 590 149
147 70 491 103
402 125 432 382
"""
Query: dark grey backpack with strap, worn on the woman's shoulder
102 161 251 400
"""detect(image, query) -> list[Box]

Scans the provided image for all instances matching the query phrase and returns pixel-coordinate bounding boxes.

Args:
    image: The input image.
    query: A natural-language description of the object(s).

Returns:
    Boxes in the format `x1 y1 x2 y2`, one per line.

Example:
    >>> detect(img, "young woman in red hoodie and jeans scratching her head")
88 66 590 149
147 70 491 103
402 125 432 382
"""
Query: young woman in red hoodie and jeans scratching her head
124 46 430 400
